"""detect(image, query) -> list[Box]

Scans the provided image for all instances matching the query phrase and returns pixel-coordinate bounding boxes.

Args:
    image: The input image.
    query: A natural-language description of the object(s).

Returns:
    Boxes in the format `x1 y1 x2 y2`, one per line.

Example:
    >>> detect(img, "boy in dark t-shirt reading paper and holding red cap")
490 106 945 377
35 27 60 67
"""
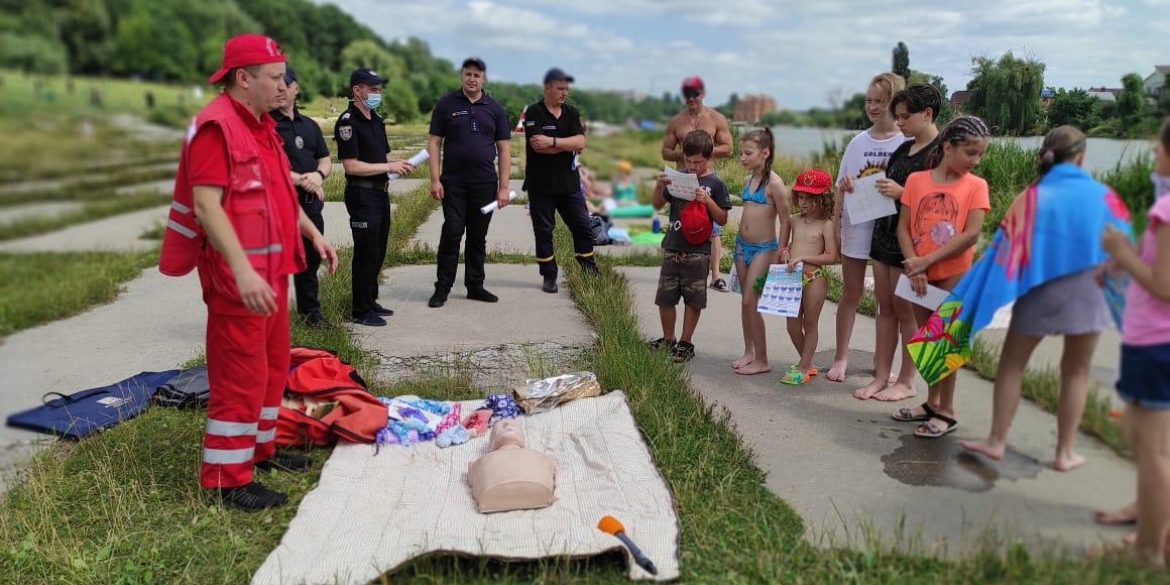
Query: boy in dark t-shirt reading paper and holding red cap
651 130 731 363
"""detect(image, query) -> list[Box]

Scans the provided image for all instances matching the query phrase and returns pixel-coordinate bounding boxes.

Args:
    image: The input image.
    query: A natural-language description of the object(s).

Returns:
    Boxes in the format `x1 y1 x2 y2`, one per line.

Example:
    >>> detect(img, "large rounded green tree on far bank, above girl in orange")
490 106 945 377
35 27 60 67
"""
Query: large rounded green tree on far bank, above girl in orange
966 51 1045 136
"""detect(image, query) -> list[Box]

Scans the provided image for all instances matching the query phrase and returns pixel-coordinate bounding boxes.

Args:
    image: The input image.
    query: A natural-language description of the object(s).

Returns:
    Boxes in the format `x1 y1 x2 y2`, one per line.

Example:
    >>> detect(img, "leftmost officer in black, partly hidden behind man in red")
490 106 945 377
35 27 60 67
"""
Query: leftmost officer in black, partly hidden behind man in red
270 67 333 326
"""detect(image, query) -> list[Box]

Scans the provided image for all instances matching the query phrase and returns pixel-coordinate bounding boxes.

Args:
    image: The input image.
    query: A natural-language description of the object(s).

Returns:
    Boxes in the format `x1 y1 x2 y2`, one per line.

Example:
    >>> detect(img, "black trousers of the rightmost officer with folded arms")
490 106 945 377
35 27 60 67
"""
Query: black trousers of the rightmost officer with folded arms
528 191 593 277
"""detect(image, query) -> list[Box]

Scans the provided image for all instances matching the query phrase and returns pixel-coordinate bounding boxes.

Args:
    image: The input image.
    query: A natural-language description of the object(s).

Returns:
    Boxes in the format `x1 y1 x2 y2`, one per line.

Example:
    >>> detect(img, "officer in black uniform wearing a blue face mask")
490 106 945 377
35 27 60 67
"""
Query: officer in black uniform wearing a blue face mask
333 69 413 326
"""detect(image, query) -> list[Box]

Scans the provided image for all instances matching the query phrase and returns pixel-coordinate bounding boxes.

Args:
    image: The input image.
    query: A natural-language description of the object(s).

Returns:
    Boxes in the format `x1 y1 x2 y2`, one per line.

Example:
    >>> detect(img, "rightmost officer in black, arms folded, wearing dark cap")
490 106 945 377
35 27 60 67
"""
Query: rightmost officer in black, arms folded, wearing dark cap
524 68 597 293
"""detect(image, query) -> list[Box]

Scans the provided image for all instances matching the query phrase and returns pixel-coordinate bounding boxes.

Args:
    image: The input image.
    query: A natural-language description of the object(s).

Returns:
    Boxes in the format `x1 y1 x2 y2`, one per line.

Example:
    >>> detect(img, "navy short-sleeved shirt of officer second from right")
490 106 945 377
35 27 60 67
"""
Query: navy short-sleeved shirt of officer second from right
429 88 511 183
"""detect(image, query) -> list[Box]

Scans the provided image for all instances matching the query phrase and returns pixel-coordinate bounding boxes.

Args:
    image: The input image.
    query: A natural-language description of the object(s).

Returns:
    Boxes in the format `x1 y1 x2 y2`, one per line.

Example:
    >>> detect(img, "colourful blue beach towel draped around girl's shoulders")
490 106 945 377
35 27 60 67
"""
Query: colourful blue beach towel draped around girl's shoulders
907 163 1130 384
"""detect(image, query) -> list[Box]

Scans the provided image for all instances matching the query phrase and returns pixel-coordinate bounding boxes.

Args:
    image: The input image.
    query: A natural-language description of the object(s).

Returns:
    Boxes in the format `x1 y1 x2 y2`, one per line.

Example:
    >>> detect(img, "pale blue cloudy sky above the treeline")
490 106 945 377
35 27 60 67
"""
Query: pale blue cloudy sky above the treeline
315 0 1170 109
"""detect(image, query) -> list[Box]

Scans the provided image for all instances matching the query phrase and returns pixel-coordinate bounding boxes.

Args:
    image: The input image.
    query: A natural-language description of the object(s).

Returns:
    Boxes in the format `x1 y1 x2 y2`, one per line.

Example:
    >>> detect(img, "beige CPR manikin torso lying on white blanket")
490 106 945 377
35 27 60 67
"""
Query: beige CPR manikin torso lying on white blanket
467 419 556 514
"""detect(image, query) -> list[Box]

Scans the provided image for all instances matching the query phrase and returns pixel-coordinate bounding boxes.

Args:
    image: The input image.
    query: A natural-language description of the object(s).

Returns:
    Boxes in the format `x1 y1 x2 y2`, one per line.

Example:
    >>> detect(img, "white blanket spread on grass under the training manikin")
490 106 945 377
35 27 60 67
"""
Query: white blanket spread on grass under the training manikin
252 392 679 585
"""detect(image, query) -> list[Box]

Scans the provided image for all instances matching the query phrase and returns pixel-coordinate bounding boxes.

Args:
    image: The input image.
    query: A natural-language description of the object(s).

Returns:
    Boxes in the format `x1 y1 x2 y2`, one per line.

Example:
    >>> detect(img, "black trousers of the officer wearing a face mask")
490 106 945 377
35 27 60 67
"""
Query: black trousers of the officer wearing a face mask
345 186 390 317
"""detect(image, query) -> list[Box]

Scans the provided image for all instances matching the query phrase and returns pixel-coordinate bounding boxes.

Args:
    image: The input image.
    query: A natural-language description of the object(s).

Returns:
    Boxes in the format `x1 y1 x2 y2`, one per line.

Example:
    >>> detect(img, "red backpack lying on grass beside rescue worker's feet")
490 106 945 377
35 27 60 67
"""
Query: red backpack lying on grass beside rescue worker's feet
276 347 390 447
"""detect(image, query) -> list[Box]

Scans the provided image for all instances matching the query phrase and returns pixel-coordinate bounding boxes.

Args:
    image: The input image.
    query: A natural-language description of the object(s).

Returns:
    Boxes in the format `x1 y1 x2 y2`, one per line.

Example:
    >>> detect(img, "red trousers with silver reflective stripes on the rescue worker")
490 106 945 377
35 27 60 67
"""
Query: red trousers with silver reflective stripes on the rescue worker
199 276 289 488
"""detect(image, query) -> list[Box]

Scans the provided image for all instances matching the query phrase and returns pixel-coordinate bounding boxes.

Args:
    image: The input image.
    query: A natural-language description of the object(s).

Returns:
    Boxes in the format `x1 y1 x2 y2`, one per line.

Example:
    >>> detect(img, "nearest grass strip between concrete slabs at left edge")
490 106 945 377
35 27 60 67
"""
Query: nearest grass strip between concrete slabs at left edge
0 252 158 337
